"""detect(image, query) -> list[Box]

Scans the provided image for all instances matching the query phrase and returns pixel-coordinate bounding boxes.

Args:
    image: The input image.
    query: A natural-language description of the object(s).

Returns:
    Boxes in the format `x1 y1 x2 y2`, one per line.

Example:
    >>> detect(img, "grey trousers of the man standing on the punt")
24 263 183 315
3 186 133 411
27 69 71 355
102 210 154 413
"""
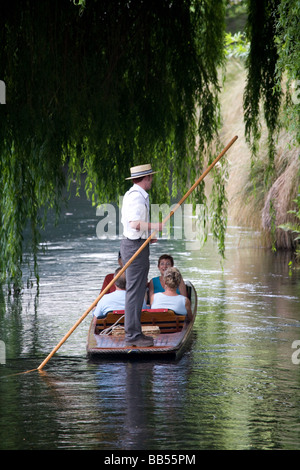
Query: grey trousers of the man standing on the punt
120 238 149 340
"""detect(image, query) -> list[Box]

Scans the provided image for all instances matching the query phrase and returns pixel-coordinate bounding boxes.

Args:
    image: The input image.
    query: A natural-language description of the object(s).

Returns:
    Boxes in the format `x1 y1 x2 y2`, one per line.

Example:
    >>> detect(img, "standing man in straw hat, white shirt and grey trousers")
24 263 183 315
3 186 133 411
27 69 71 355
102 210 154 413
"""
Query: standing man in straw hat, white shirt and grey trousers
121 164 163 347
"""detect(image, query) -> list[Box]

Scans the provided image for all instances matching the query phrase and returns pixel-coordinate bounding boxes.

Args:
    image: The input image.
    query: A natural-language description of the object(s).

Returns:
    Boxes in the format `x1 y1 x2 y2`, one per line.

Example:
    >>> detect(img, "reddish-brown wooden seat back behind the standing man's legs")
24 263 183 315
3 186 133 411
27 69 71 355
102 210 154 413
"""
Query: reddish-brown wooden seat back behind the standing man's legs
95 309 186 334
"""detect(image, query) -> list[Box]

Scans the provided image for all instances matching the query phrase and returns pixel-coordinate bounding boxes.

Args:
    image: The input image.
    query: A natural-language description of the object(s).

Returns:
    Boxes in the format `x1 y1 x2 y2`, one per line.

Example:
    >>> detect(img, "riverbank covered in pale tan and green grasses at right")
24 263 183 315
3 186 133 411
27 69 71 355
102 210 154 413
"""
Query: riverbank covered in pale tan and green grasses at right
220 59 300 249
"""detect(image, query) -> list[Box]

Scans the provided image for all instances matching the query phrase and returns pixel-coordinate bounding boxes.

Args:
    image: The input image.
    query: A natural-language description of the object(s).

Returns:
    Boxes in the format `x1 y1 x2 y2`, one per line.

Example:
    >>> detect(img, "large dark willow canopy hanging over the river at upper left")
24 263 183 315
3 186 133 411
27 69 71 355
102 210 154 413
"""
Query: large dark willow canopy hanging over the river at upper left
0 0 224 280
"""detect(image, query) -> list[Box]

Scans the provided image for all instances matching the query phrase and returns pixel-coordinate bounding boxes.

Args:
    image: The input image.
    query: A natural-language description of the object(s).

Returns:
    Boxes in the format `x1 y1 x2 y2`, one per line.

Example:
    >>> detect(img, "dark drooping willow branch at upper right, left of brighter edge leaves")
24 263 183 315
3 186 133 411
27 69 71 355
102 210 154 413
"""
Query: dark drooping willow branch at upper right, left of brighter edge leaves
244 0 282 185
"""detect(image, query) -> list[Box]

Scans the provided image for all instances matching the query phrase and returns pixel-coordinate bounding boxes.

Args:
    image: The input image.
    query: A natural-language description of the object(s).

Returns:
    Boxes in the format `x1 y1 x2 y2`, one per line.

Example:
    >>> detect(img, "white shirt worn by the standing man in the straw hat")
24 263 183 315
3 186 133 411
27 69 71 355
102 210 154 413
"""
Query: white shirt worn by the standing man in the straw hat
121 184 149 240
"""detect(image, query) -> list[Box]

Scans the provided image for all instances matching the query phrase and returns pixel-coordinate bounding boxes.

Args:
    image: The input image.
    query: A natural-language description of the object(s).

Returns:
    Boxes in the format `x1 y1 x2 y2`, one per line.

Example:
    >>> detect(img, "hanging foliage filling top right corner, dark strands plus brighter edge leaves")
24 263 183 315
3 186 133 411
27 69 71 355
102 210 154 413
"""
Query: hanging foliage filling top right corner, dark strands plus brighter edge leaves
244 0 300 176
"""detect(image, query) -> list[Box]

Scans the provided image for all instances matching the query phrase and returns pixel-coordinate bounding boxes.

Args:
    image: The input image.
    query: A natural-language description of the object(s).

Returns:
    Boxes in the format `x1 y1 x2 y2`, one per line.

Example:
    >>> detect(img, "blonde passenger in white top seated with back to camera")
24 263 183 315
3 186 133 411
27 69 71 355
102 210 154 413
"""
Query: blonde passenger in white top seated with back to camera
151 267 192 320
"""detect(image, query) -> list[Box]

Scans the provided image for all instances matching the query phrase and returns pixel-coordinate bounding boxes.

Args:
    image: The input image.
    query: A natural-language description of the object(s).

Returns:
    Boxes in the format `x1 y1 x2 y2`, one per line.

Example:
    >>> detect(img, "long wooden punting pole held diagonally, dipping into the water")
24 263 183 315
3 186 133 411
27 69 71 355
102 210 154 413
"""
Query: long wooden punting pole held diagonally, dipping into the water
37 136 238 371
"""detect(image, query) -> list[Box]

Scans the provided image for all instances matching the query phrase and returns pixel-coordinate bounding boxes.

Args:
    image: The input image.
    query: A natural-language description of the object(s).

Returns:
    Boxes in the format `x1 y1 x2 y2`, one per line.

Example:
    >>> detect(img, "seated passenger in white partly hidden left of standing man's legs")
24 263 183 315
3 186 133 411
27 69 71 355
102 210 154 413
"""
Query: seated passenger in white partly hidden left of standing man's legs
94 268 126 318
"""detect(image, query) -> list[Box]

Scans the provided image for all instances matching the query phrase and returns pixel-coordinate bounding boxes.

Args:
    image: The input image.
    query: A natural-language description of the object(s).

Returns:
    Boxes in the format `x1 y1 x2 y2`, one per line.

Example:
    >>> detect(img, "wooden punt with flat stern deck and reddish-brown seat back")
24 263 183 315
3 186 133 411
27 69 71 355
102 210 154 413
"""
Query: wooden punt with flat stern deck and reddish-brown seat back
87 282 197 357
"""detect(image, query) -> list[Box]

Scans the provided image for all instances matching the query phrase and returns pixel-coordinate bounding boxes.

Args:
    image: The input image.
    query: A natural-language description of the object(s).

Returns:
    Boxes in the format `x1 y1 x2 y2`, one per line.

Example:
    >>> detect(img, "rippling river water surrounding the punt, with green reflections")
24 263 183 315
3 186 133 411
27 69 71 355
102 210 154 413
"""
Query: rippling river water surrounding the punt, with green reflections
0 193 300 451
